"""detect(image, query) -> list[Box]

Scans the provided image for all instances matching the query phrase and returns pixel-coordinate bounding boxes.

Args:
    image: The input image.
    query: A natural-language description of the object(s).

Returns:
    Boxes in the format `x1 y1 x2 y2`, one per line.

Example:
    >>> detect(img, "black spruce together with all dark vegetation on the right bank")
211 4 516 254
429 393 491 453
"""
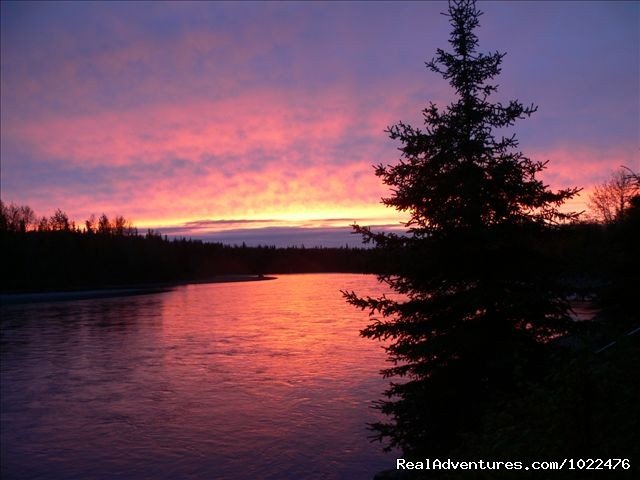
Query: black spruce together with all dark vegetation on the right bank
344 0 640 478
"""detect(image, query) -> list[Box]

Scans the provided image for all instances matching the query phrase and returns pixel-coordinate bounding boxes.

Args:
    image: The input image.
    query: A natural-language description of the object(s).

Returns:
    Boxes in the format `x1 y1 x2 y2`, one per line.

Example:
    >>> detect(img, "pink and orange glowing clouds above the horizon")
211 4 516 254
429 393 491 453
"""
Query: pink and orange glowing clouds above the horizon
3 70 637 231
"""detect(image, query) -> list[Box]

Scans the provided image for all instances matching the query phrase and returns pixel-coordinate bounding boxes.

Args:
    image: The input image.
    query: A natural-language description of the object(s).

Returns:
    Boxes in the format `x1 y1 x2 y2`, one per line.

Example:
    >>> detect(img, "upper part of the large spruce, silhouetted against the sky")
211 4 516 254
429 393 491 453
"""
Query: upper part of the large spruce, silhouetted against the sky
376 0 579 240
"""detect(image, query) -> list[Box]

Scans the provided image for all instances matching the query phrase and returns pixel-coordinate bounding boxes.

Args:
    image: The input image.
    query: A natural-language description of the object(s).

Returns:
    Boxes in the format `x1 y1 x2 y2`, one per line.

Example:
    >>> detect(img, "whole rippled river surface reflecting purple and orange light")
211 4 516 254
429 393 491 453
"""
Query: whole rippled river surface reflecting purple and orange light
0 274 395 479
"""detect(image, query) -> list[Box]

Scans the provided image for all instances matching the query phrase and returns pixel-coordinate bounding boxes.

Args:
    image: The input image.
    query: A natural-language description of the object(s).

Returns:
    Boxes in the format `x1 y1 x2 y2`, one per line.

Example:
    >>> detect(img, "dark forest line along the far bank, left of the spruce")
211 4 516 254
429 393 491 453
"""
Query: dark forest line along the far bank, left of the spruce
0 203 381 292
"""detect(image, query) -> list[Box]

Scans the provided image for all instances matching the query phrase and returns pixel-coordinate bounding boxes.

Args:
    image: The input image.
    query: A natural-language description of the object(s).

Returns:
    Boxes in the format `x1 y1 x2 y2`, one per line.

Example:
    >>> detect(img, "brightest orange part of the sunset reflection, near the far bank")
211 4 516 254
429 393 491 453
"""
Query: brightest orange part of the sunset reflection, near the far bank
162 275 384 384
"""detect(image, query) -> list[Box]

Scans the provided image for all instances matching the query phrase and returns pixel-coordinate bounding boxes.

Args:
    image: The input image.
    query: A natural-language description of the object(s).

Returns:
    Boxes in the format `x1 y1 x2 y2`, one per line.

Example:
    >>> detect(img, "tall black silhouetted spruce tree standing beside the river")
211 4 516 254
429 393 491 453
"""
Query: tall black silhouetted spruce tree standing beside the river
345 0 578 456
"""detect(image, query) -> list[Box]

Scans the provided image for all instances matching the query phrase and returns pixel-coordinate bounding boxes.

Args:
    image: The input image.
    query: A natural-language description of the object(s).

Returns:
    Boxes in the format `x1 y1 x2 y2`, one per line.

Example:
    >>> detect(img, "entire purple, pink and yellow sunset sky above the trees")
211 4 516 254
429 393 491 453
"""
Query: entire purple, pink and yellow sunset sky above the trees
1 1 640 246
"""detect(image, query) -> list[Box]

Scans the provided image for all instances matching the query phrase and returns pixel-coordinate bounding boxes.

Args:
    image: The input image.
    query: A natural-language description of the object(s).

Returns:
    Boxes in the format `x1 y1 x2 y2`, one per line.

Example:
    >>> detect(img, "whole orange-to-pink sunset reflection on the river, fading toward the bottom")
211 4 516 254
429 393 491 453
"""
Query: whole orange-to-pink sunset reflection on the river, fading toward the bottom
151 275 396 478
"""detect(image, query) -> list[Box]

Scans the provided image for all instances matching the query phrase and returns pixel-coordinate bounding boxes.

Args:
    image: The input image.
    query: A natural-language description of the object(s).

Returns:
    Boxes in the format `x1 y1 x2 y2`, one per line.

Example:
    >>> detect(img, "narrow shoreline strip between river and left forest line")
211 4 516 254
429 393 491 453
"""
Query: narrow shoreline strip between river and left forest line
0 275 277 305
